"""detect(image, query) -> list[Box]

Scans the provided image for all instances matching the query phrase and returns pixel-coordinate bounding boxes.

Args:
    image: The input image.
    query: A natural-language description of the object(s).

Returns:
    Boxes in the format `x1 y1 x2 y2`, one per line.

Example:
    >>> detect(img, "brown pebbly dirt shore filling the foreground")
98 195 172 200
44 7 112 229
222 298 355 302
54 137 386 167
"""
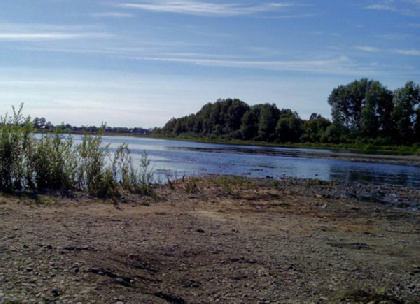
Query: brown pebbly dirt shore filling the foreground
0 178 420 304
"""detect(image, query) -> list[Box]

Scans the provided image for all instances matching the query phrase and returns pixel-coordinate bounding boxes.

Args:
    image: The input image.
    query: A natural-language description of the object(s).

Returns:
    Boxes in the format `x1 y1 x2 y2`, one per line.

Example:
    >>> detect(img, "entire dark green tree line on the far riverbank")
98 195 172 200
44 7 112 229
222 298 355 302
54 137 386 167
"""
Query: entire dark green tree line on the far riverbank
153 78 420 145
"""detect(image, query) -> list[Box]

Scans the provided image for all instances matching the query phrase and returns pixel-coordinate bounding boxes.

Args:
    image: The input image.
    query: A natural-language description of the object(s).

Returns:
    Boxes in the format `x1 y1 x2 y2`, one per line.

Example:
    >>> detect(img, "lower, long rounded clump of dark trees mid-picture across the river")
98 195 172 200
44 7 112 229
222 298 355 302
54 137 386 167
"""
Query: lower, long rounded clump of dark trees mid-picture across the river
159 99 303 142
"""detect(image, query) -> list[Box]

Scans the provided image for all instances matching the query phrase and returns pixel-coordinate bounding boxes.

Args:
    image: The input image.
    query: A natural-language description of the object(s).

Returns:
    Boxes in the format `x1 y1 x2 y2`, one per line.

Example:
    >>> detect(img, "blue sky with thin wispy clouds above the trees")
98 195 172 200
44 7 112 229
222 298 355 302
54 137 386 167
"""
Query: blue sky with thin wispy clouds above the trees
0 0 420 128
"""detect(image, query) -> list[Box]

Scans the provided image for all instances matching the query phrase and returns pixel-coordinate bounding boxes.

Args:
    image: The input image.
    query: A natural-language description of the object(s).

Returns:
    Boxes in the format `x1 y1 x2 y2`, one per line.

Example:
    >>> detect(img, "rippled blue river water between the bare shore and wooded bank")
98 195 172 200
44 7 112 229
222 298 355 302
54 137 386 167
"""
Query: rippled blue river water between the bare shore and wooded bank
99 136 420 189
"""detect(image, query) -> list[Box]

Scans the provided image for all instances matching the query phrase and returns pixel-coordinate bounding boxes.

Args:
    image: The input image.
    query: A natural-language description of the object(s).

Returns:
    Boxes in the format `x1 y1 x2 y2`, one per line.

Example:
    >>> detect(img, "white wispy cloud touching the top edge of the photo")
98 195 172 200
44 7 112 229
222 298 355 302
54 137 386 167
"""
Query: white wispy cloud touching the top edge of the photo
120 0 294 16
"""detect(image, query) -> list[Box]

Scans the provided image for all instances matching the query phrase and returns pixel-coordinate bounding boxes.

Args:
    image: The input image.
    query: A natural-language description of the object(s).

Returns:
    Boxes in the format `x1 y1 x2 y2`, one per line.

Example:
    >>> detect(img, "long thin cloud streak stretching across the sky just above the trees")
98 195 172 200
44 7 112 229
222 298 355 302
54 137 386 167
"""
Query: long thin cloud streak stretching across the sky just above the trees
11 39 377 75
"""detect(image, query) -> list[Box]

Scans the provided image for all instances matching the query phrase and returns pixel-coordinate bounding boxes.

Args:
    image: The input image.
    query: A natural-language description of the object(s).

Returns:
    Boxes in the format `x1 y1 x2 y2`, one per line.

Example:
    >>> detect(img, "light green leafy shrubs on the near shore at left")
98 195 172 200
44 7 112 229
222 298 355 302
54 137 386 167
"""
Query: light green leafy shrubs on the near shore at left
0 105 154 197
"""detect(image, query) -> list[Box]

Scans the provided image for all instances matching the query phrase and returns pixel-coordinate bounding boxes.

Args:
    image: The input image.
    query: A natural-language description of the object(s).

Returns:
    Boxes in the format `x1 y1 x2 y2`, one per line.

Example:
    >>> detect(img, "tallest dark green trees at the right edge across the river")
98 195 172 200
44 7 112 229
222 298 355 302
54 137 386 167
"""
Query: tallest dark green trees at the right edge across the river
326 78 420 145
